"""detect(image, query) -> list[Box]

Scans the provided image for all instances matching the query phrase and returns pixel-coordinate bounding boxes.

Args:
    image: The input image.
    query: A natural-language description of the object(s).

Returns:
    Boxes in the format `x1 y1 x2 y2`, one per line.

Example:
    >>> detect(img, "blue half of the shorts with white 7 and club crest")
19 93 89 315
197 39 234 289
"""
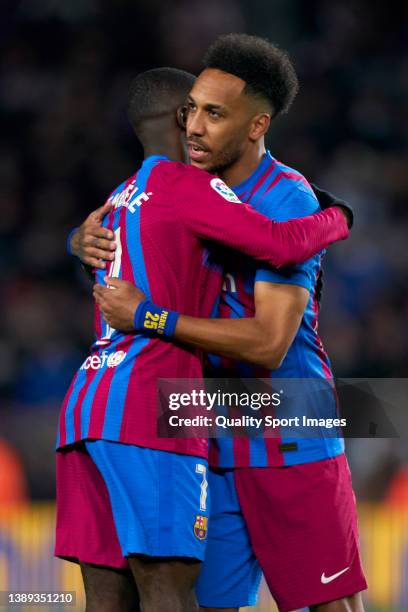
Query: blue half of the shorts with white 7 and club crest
85 440 209 560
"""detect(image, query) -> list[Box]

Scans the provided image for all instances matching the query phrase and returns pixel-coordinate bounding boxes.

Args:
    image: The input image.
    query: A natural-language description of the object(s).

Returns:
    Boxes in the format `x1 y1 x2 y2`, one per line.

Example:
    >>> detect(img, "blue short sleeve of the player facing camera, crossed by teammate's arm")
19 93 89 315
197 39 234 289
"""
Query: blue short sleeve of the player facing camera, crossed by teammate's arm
255 191 322 292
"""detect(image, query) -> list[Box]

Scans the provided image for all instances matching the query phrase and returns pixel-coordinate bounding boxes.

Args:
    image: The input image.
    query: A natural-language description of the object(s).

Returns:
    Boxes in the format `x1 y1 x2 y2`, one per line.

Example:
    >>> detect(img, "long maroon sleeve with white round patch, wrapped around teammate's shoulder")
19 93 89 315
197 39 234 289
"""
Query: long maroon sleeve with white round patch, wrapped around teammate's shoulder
172 167 348 268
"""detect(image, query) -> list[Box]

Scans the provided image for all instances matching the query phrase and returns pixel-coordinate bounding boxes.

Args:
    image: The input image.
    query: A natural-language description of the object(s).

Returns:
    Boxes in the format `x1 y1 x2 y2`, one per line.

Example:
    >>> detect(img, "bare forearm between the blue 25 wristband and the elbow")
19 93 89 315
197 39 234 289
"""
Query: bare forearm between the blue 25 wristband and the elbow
174 315 284 369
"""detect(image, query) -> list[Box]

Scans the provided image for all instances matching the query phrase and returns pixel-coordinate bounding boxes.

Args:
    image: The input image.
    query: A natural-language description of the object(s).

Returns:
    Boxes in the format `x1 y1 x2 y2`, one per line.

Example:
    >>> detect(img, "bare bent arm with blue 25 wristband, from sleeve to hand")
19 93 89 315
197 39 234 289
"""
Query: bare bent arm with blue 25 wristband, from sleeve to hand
94 279 309 369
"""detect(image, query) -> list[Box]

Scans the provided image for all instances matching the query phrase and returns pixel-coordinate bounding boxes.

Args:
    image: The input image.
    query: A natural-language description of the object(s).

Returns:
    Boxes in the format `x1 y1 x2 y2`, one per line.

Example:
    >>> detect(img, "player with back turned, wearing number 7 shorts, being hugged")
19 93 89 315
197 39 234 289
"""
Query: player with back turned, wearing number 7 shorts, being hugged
56 68 348 612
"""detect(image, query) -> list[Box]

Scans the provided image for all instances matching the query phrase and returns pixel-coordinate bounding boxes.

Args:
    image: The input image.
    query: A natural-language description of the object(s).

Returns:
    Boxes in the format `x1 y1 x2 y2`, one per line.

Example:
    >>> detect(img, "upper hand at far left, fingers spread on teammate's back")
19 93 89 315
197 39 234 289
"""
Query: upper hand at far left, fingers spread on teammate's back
70 202 116 270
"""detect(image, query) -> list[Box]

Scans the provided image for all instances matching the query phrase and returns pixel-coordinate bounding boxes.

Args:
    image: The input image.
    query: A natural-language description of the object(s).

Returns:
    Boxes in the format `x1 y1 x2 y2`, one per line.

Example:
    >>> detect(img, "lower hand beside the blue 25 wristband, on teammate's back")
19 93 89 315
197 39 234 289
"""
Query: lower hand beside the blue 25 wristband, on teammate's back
93 276 146 332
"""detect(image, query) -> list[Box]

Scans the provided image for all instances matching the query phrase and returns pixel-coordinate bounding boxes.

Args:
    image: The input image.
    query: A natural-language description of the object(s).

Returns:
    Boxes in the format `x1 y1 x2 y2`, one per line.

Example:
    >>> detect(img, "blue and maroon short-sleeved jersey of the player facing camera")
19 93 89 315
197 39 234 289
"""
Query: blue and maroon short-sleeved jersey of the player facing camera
210 152 344 467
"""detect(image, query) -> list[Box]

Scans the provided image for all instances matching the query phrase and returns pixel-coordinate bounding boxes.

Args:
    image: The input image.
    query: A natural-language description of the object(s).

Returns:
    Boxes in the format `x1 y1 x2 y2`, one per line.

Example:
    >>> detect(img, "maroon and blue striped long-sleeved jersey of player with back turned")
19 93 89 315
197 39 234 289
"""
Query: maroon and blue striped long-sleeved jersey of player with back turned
57 156 348 456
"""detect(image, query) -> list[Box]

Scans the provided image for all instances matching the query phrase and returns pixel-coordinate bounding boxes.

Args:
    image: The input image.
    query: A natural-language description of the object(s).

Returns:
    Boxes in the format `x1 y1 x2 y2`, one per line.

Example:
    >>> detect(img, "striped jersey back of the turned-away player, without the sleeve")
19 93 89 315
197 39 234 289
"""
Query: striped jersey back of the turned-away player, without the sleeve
59 156 222 456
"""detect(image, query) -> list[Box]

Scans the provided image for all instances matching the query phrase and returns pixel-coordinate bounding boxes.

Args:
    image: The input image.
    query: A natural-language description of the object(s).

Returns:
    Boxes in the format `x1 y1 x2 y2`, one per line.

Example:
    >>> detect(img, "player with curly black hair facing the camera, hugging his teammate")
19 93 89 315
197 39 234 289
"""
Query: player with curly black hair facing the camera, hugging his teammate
95 34 366 612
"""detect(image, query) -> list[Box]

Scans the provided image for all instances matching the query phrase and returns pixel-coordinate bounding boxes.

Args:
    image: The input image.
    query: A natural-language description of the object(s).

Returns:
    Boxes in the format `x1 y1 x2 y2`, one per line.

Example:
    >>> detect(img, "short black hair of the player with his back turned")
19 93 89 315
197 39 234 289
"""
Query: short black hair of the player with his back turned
128 68 195 131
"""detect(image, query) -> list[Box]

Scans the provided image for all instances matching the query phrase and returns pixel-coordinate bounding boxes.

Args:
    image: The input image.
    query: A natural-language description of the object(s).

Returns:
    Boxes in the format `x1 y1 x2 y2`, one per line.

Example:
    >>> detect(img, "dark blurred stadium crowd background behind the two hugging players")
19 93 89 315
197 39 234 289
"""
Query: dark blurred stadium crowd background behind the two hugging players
0 0 408 612
